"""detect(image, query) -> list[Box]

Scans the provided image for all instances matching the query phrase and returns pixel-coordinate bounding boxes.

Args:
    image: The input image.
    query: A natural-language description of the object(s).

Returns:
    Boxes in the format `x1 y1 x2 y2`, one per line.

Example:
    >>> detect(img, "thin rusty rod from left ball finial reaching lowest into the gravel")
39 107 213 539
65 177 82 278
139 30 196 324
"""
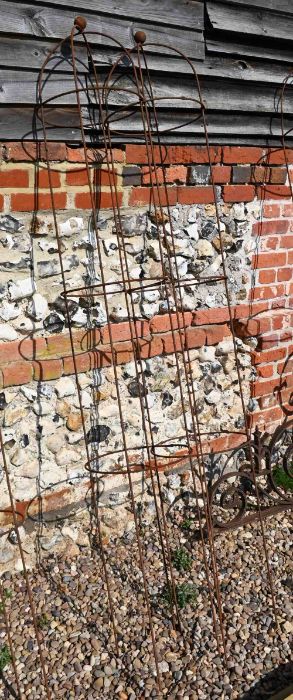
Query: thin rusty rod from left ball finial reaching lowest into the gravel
71 30 162 691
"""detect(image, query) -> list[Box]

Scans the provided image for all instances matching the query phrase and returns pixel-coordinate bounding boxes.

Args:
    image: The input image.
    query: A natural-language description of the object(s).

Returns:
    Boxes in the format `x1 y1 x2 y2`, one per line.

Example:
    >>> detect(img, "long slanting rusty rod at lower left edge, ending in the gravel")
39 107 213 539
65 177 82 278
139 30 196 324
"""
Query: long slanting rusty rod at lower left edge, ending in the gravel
0 428 52 700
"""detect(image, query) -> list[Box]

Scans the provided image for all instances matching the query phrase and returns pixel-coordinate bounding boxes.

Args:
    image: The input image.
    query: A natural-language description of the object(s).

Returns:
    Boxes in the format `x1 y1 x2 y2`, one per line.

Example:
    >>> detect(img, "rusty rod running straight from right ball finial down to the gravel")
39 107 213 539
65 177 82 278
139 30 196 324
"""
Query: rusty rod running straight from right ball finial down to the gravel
138 47 226 655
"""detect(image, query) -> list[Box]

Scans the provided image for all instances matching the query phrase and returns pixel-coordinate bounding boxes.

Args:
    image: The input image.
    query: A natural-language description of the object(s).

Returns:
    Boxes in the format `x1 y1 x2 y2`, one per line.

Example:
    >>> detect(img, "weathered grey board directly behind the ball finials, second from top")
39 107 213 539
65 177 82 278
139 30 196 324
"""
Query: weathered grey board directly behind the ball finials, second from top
0 0 204 59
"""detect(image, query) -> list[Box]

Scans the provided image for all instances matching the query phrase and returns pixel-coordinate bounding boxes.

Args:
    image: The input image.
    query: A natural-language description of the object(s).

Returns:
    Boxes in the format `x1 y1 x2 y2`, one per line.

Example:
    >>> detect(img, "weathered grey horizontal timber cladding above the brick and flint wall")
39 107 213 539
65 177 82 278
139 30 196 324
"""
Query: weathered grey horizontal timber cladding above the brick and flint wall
0 0 293 144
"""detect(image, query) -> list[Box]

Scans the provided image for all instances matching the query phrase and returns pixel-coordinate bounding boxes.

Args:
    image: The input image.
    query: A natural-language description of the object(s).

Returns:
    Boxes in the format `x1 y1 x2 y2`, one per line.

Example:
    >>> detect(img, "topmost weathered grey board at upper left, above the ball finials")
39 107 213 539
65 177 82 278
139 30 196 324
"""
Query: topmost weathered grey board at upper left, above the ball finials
32 0 203 29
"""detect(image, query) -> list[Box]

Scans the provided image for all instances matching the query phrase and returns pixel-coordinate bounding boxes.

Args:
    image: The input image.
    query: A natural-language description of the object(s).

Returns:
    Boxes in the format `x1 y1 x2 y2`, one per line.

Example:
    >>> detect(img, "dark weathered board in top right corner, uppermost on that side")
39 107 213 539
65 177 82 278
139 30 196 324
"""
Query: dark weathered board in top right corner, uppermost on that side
207 0 293 42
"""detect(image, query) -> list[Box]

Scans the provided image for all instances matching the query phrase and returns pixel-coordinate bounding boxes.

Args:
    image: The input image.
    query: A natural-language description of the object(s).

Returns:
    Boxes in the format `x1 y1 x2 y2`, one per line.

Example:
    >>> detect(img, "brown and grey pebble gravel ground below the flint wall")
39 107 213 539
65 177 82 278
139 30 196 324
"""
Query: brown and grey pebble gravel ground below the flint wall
0 514 293 700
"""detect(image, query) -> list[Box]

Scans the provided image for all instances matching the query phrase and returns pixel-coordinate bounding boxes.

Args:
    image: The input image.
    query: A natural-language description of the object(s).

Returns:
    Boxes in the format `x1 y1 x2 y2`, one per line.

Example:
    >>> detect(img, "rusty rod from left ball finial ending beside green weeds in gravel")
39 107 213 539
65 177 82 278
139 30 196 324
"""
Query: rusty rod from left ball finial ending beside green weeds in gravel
84 36 181 625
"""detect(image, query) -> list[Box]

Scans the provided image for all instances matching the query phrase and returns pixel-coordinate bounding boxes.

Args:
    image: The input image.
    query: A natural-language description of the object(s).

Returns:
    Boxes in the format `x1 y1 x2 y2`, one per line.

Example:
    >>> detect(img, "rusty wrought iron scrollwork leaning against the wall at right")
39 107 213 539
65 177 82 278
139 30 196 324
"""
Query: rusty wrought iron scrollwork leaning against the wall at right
209 420 293 530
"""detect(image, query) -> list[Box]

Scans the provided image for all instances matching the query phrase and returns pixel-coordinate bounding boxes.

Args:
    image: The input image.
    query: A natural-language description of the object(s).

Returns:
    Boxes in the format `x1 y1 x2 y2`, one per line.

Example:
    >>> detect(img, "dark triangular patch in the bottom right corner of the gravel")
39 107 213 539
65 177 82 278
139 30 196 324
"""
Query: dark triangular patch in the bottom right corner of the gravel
239 662 293 700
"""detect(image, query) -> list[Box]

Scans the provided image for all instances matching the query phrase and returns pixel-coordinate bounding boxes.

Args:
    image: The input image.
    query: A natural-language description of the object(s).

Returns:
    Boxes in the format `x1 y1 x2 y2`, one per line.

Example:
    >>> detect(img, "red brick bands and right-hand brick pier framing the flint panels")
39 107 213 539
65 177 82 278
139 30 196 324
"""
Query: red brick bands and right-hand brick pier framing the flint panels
0 143 293 427
